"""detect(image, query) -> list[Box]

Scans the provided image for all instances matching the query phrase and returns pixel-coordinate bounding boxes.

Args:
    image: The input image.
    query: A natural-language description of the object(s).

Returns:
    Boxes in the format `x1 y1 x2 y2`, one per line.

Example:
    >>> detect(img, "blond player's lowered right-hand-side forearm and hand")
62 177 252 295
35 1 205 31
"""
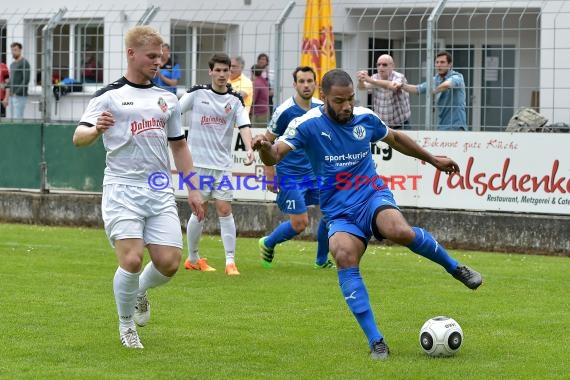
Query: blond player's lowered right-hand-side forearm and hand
170 136 204 220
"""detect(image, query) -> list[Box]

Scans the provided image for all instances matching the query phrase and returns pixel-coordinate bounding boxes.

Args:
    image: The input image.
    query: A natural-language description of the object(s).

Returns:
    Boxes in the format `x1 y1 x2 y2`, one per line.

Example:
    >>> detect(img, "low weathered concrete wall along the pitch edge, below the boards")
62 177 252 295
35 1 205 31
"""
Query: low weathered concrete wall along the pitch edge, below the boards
0 192 570 257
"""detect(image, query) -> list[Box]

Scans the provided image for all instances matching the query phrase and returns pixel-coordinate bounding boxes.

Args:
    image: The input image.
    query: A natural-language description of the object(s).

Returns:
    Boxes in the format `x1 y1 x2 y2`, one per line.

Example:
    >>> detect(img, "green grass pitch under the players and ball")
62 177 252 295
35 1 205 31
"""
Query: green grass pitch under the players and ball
0 224 570 380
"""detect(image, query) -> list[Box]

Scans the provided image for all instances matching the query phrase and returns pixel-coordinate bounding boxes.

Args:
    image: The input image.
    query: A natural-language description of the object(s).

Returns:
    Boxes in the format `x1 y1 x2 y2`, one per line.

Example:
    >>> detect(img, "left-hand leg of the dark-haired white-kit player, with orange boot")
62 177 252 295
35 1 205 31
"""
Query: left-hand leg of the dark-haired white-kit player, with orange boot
184 167 215 272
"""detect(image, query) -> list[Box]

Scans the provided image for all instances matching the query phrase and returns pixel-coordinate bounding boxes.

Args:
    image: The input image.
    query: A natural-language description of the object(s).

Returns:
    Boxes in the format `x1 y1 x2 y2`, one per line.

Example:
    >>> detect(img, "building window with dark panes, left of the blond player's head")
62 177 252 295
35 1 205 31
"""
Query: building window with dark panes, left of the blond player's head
34 19 104 85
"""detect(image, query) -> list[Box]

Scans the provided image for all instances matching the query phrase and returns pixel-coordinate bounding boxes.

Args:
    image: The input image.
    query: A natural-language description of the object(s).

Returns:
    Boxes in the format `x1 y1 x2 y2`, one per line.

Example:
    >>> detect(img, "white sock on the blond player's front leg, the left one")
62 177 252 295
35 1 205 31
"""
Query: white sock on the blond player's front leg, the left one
113 267 140 331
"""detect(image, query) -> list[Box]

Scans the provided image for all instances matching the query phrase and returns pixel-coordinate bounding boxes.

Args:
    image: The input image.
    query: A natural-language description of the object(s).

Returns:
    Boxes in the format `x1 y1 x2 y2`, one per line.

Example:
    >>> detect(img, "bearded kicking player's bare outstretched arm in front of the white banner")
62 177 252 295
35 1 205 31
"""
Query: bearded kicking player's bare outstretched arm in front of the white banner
380 129 459 174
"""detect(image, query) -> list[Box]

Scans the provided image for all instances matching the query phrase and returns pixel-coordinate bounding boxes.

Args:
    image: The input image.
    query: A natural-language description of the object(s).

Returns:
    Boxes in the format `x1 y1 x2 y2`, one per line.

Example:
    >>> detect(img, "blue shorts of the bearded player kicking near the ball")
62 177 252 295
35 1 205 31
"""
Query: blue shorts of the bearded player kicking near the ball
328 190 399 244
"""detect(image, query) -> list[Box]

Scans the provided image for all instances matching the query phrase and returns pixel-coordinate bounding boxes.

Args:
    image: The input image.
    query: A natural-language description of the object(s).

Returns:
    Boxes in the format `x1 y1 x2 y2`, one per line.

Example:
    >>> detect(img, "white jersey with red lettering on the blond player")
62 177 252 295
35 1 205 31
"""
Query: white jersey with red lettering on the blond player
79 77 184 191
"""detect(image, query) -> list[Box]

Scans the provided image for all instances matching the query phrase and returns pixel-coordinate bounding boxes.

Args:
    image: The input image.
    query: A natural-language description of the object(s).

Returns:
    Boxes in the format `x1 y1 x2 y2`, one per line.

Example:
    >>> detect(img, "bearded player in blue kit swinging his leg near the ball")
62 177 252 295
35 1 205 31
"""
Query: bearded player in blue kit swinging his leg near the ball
252 69 483 359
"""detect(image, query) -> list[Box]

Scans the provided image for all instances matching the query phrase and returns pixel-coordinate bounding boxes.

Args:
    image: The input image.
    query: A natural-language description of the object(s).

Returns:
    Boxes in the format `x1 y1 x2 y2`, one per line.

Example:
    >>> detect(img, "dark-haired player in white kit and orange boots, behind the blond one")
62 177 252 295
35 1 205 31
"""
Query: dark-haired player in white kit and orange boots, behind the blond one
180 53 253 276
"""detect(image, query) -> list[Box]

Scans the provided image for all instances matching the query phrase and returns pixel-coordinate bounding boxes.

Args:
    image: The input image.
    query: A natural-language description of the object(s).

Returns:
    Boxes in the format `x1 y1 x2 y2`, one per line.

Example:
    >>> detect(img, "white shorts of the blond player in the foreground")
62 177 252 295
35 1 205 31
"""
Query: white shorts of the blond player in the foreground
101 184 183 249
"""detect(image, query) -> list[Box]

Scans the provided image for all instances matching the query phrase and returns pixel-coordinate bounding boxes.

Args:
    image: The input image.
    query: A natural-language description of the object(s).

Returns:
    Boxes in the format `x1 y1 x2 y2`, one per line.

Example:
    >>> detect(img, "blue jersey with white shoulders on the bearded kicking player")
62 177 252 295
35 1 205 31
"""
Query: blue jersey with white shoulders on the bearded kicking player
280 107 389 220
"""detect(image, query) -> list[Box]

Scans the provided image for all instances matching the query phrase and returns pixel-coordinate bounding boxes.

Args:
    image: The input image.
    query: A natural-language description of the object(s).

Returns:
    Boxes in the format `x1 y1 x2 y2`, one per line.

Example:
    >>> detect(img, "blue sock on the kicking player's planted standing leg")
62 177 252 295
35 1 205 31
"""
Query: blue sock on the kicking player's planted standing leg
337 267 383 347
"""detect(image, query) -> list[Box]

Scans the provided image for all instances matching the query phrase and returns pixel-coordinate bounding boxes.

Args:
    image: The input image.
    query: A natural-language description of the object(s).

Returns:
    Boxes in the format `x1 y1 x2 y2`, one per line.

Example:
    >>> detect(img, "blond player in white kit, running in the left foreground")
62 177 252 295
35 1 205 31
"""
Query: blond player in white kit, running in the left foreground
73 26 204 348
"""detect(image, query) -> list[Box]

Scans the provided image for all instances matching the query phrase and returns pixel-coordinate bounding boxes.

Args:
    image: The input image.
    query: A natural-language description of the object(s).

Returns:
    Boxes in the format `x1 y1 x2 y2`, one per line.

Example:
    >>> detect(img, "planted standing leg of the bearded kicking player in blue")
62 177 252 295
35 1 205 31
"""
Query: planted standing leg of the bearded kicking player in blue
329 220 388 359
